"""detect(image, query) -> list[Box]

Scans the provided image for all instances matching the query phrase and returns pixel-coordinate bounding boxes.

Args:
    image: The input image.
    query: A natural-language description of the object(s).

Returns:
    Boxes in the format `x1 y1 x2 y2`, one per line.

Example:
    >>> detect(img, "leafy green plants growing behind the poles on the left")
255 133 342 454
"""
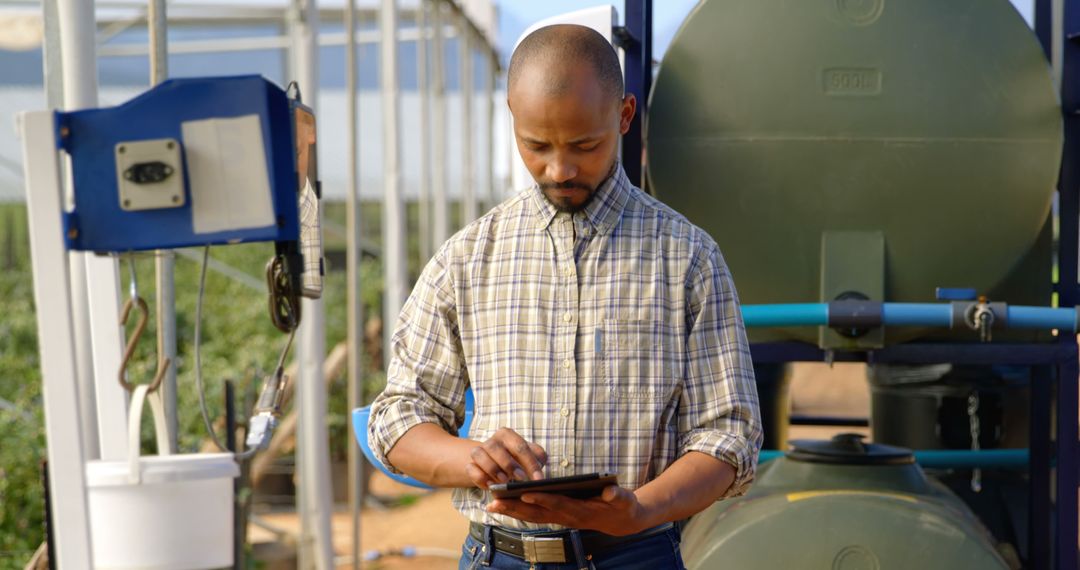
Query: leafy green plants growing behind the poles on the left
0 194 457 570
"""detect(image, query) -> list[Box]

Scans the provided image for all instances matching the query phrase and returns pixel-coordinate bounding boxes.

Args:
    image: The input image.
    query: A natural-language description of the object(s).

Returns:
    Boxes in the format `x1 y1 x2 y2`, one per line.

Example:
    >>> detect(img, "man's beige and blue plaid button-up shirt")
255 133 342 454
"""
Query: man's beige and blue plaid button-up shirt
368 167 761 528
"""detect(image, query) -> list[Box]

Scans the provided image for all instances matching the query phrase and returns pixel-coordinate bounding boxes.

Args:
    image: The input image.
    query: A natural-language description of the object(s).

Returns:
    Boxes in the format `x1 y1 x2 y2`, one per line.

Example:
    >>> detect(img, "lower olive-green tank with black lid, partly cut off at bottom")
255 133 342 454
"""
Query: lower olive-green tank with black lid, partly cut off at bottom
681 434 1016 570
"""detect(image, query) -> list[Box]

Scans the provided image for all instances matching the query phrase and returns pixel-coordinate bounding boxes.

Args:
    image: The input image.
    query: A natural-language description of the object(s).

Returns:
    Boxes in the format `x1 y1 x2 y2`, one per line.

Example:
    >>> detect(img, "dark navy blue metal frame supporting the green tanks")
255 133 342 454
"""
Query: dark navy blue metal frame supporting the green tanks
623 0 1080 570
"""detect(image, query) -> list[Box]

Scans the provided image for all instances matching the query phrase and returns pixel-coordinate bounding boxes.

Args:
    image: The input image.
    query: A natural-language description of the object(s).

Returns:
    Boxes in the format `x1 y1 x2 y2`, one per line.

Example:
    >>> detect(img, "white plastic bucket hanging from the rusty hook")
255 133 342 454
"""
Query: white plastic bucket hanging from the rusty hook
86 384 240 570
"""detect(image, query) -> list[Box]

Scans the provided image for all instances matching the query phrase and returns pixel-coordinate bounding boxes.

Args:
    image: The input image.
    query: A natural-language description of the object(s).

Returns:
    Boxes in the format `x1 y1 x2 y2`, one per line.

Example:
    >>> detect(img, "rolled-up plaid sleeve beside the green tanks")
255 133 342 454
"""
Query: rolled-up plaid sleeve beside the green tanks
678 243 764 499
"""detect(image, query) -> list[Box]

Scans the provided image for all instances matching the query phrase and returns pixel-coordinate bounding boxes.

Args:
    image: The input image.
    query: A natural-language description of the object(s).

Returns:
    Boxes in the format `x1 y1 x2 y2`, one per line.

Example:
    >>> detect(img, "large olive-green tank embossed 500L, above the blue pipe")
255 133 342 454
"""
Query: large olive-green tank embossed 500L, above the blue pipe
647 0 1062 342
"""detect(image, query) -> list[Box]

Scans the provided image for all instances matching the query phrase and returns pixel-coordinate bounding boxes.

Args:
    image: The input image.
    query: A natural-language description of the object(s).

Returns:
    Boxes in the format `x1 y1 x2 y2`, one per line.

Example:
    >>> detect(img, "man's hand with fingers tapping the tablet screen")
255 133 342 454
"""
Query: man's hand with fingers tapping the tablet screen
465 428 548 489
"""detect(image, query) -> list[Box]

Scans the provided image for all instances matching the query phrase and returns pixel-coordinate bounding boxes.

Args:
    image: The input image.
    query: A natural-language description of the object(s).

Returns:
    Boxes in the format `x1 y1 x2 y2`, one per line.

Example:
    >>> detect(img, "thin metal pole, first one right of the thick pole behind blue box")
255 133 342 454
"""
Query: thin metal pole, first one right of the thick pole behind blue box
345 0 364 570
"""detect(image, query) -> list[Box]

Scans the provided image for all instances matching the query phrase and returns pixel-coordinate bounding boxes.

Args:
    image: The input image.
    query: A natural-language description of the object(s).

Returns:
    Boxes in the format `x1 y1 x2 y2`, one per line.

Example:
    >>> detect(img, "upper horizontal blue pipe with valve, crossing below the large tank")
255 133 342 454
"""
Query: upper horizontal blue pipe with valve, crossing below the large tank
742 303 1077 333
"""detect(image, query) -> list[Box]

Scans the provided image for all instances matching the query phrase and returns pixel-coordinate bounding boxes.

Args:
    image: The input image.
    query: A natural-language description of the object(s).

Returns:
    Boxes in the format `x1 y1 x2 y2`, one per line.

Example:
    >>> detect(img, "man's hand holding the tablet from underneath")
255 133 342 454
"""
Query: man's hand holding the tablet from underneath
487 485 659 537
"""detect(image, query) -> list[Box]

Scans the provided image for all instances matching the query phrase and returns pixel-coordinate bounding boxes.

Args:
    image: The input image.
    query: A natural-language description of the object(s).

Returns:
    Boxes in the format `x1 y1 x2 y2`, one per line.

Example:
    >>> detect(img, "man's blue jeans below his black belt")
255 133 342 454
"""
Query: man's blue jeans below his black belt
458 527 686 570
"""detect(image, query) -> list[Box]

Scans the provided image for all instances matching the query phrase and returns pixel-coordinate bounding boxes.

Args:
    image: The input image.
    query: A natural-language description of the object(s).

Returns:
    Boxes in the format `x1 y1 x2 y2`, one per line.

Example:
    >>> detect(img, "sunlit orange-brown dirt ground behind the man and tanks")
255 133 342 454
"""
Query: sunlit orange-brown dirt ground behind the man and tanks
251 364 869 570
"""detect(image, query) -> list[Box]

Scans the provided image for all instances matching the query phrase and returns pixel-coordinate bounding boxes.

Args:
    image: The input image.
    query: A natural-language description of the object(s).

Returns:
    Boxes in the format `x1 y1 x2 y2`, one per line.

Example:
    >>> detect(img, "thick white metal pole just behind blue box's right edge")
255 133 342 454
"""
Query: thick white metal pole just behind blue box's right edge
291 0 334 570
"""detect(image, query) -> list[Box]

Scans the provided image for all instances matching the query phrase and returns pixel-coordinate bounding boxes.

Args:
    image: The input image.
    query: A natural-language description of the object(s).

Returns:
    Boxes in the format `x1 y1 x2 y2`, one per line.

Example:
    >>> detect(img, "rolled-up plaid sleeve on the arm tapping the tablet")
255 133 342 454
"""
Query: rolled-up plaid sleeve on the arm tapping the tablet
367 252 469 473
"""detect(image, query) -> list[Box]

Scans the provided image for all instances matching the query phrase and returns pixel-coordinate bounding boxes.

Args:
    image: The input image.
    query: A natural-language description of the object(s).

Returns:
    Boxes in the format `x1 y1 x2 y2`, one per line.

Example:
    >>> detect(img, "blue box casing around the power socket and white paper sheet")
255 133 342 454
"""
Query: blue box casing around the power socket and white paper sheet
56 76 299 252
